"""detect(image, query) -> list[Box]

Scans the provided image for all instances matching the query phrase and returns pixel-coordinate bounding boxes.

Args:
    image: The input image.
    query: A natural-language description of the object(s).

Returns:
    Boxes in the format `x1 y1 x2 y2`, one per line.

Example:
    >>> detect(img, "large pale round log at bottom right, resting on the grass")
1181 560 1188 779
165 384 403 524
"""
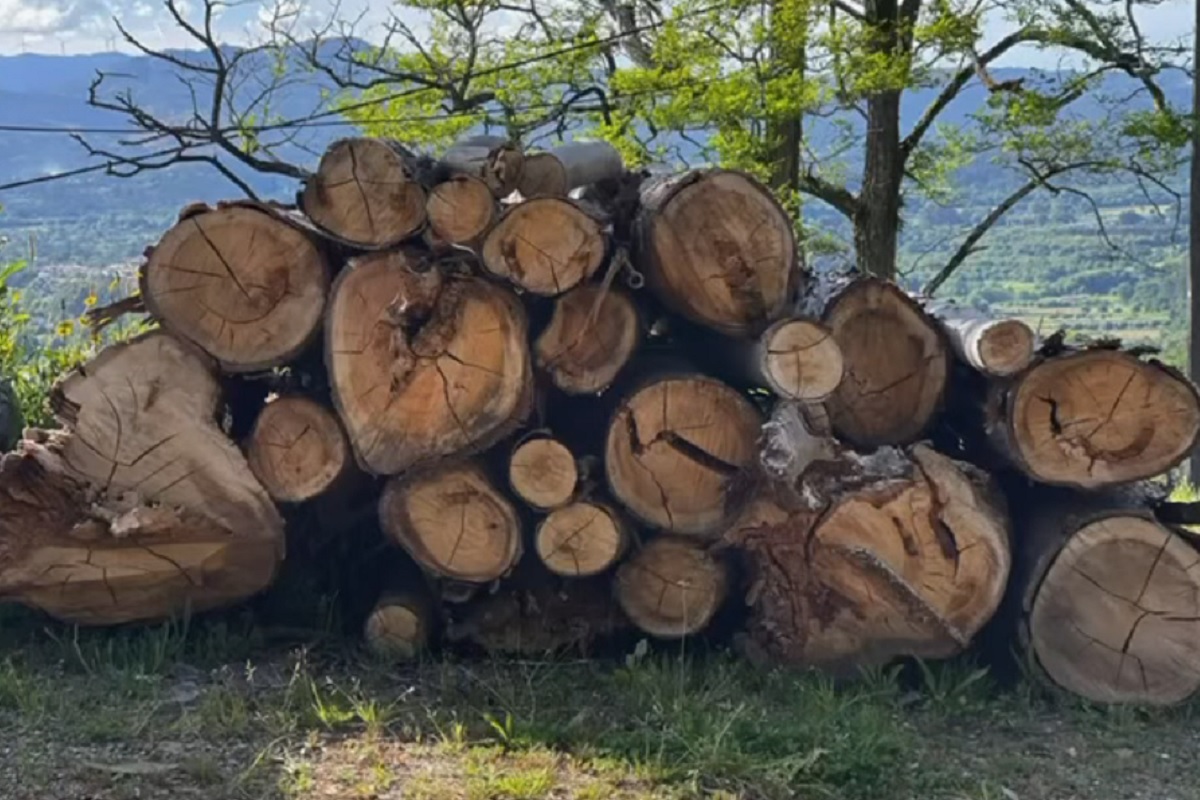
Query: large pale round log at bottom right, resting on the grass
1013 488 1200 705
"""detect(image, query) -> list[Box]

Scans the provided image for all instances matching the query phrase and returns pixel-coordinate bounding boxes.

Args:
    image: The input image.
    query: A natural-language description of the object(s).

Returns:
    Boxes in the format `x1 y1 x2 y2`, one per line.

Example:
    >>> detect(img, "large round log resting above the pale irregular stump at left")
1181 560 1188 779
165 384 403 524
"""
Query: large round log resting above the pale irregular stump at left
140 205 330 372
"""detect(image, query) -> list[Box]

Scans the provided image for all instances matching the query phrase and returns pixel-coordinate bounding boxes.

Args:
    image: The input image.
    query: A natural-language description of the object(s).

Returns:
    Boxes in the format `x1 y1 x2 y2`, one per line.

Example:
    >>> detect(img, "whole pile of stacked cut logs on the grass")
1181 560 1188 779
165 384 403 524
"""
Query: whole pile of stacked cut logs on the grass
0 137 1200 703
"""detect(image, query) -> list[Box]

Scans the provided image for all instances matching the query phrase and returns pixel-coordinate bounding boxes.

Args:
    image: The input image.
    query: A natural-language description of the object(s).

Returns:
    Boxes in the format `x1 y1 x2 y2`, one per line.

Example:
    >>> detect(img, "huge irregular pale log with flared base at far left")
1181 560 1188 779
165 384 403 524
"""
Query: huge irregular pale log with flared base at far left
0 331 283 625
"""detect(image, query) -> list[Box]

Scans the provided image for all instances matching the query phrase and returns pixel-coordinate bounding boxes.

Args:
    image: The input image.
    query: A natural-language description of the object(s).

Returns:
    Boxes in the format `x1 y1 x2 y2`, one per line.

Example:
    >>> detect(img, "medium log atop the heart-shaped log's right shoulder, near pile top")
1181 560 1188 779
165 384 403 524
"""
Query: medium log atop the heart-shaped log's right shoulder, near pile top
480 197 607 297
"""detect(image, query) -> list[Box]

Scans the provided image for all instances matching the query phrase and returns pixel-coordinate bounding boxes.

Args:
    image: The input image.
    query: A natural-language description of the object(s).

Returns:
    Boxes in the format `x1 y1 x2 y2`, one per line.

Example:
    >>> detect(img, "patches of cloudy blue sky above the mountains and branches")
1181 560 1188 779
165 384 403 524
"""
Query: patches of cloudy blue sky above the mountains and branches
0 0 1195 66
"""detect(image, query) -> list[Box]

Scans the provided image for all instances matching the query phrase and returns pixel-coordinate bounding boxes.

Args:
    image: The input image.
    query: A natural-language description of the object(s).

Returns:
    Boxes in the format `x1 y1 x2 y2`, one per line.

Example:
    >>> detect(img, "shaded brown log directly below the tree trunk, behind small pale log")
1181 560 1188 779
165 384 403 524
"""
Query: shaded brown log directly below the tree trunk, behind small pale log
823 278 949 447
